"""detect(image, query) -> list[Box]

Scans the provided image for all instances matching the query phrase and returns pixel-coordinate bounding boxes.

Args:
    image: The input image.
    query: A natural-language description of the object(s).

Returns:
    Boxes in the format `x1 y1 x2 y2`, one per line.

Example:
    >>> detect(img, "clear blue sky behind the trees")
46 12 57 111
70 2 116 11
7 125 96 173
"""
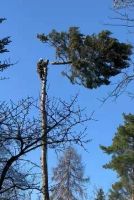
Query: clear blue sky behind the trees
0 0 134 199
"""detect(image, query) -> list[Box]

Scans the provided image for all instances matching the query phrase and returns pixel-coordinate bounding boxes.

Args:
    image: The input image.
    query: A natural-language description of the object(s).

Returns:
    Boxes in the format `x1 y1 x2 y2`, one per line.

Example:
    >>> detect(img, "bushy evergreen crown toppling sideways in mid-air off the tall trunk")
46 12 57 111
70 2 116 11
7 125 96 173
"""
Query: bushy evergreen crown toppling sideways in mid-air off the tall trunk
37 27 132 89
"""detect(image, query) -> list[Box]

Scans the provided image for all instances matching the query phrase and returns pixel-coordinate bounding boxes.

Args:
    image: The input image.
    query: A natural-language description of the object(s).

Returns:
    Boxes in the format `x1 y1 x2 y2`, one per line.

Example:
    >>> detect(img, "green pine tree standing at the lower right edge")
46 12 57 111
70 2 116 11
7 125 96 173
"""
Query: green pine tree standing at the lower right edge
101 114 134 200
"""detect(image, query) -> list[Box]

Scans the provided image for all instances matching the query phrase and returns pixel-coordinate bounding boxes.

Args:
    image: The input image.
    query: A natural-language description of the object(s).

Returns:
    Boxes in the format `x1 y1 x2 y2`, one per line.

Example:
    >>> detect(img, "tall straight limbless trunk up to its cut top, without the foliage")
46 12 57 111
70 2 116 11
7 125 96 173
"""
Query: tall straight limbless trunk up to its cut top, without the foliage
37 60 49 200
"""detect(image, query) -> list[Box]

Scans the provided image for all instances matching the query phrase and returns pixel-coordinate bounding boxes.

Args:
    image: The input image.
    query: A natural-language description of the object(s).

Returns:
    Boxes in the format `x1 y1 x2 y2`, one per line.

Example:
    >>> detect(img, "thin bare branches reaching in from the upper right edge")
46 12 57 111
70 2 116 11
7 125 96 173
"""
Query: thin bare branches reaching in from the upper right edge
102 0 134 102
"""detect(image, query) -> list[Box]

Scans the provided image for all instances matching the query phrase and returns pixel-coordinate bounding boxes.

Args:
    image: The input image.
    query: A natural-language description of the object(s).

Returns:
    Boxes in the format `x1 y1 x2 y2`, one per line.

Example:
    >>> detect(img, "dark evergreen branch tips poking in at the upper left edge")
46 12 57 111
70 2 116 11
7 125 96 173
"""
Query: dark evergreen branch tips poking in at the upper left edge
0 18 12 72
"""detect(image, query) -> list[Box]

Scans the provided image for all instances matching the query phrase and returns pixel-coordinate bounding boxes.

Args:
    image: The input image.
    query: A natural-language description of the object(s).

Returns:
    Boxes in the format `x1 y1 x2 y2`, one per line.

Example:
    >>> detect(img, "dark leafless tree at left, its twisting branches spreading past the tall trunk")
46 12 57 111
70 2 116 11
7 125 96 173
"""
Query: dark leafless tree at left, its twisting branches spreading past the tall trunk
0 93 88 200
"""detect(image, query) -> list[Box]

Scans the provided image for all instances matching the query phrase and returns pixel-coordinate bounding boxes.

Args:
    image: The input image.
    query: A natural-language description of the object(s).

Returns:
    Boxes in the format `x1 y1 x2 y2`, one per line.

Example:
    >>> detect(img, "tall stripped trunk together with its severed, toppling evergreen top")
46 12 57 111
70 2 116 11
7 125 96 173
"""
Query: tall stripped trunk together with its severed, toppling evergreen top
37 27 132 200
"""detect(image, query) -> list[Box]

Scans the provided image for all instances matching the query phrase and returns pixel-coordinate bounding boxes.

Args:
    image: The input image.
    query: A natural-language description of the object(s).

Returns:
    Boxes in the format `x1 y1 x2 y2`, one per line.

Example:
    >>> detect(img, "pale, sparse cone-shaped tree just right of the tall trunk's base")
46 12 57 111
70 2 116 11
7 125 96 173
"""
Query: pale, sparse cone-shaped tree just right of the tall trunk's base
51 147 89 200
